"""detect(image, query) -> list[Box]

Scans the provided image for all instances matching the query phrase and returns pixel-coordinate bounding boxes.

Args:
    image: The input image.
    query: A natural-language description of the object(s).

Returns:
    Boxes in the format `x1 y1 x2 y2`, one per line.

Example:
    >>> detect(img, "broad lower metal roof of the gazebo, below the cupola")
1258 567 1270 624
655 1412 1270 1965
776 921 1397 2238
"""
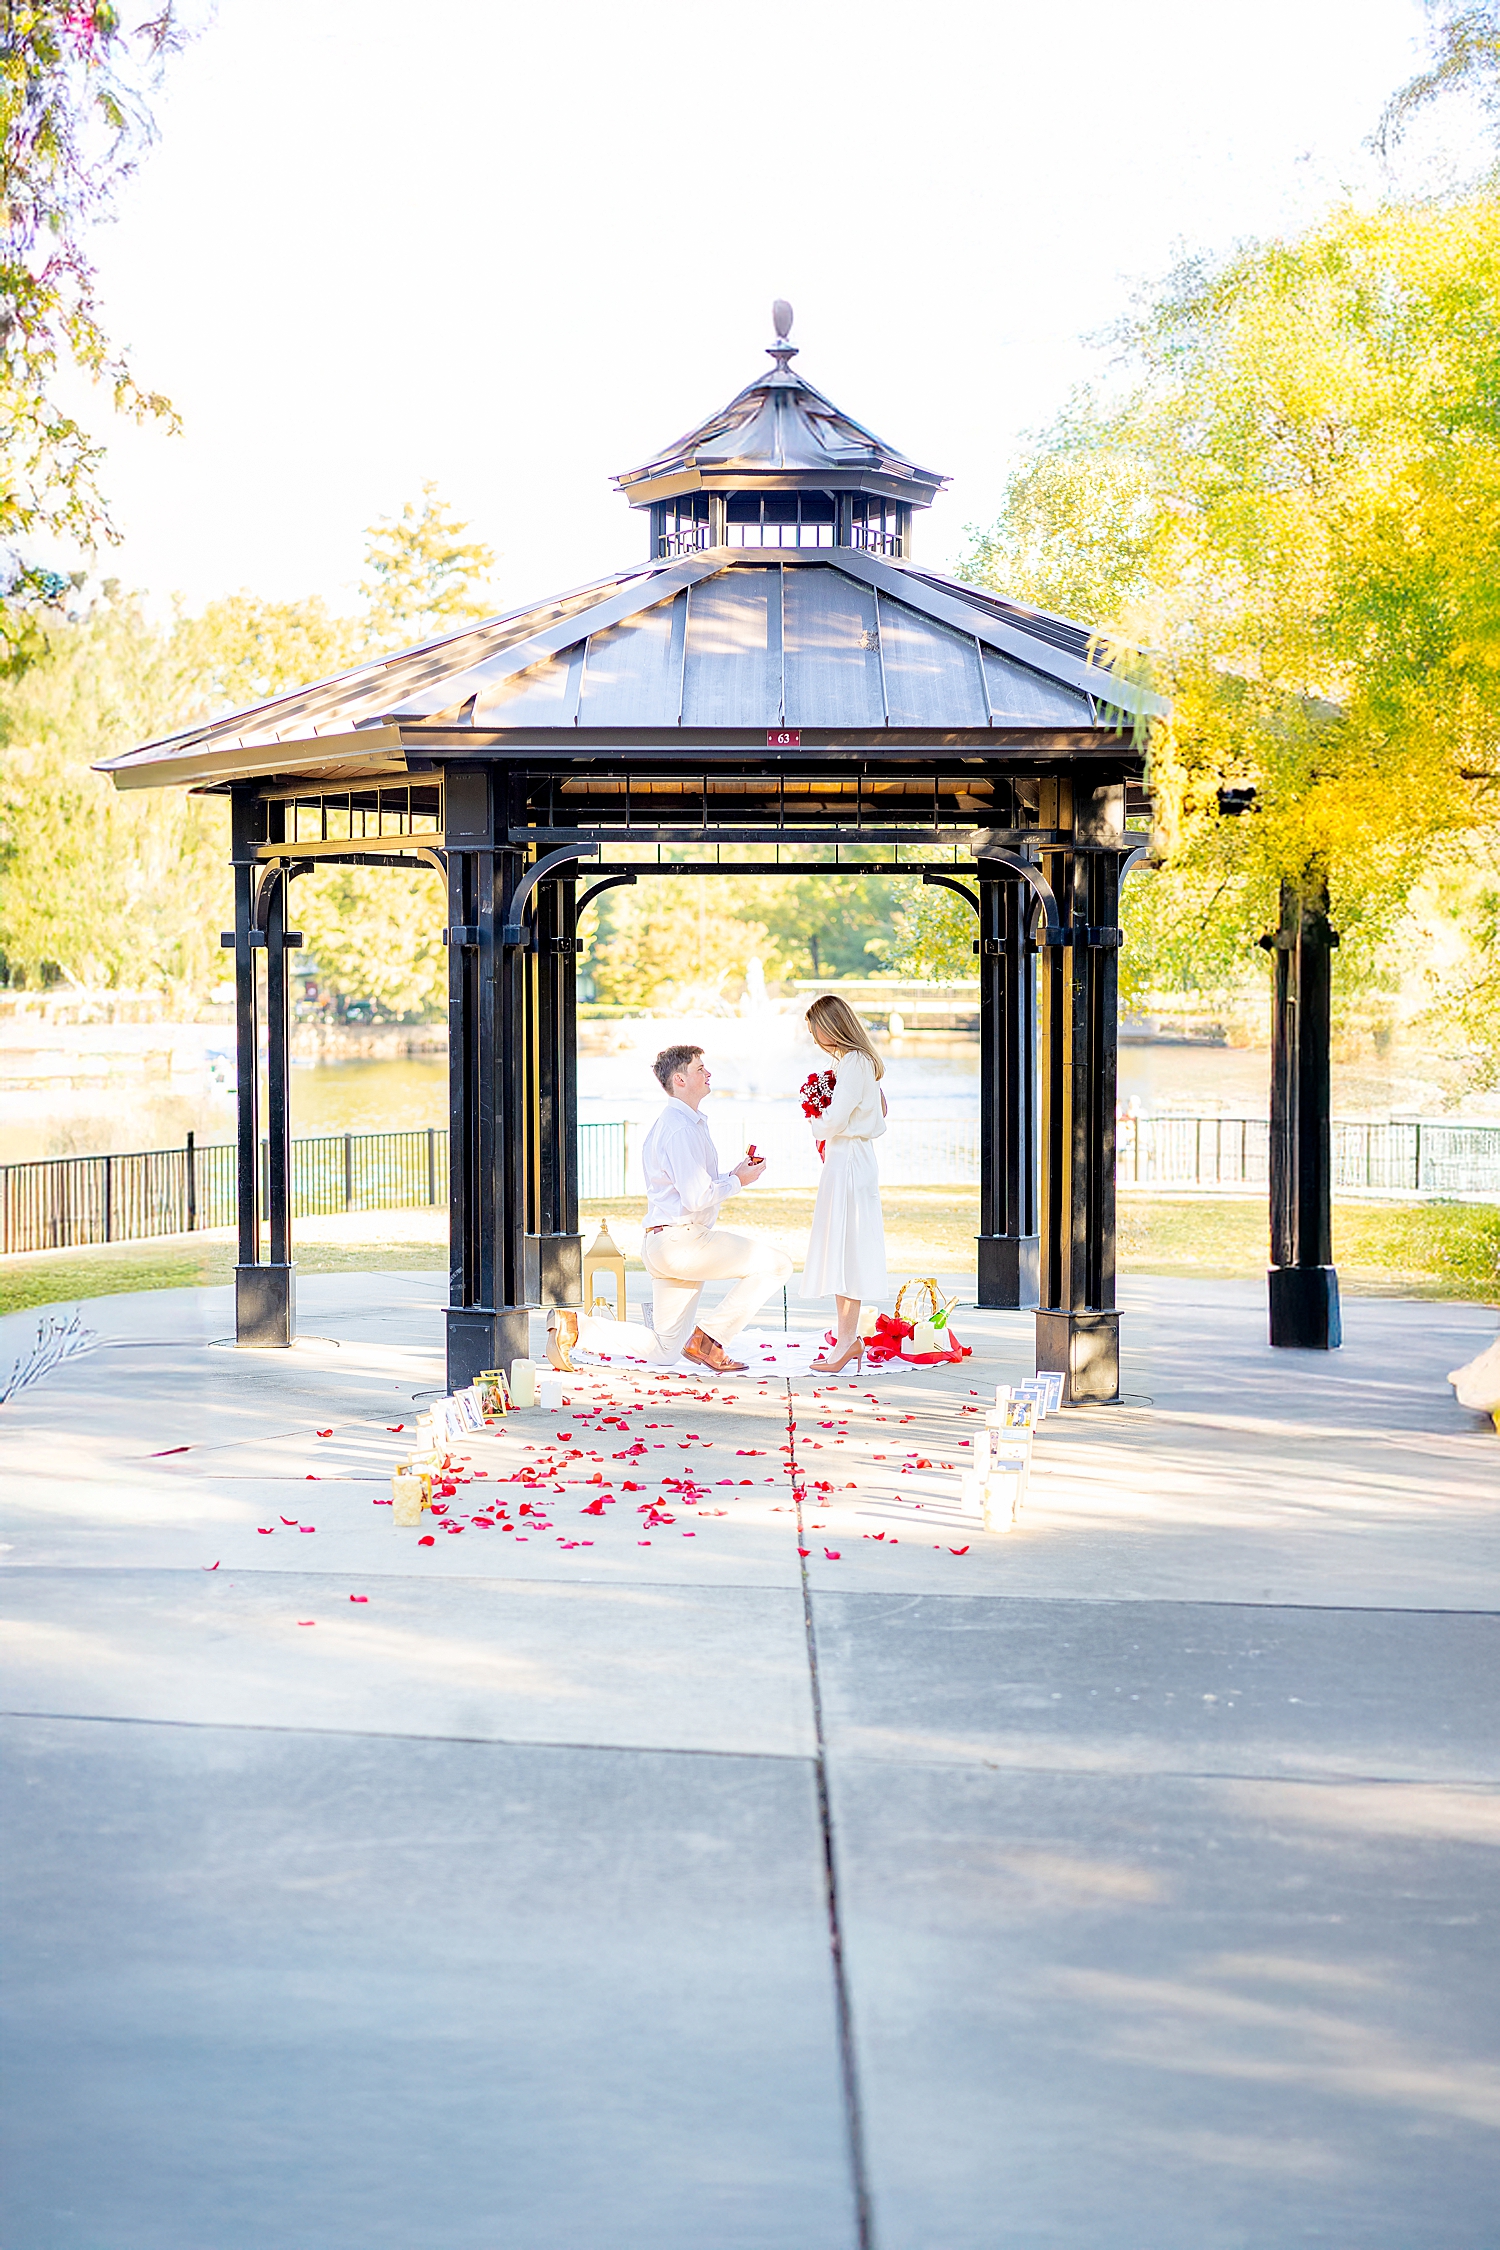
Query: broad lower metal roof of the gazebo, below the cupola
97 547 1165 790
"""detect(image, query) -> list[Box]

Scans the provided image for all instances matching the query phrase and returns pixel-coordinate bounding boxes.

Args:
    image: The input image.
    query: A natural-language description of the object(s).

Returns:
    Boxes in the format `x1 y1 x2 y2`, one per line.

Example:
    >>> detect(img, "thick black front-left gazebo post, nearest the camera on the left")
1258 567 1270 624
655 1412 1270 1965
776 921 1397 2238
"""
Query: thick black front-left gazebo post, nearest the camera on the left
445 767 531 1391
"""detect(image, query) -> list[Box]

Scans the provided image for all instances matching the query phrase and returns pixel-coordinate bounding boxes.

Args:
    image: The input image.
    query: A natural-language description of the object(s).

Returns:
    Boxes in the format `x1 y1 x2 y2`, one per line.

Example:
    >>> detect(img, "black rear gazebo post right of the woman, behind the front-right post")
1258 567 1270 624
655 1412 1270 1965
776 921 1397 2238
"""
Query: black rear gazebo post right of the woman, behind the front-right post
976 860 1039 1310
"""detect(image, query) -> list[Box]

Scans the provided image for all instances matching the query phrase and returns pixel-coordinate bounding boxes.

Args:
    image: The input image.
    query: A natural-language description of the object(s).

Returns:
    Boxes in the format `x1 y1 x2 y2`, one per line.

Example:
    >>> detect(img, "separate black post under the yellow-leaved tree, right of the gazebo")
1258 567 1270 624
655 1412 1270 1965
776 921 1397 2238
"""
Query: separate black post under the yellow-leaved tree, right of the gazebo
1262 871 1343 1352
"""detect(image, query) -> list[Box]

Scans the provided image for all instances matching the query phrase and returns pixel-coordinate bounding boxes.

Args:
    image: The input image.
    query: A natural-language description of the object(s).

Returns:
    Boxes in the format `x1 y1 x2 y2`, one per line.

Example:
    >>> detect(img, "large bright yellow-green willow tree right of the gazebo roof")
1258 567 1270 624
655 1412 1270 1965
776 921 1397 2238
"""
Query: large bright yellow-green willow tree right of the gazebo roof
967 194 1500 1069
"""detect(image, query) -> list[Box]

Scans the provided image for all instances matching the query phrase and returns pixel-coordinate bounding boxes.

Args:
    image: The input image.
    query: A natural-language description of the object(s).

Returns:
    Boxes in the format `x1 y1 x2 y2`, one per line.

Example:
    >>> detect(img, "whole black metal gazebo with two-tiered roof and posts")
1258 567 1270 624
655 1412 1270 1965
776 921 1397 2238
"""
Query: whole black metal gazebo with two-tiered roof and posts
101 304 1163 1402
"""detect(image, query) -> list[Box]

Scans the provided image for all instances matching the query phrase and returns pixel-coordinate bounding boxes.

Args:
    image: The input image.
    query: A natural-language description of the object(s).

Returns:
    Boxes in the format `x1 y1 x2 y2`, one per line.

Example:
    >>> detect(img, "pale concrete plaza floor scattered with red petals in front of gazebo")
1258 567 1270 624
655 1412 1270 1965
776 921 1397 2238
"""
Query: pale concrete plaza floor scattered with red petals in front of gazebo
0 1276 1500 2250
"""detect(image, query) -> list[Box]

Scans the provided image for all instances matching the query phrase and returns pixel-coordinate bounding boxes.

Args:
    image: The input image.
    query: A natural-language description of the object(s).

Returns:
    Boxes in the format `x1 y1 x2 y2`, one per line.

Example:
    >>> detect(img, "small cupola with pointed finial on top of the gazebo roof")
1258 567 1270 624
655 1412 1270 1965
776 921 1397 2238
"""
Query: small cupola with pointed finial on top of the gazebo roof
614 297 947 560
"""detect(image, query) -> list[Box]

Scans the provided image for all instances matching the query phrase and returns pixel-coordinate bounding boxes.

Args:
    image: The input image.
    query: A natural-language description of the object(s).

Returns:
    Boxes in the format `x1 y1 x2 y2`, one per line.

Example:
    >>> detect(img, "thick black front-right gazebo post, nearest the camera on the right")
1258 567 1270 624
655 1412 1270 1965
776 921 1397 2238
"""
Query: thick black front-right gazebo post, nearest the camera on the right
1037 783 1127 1406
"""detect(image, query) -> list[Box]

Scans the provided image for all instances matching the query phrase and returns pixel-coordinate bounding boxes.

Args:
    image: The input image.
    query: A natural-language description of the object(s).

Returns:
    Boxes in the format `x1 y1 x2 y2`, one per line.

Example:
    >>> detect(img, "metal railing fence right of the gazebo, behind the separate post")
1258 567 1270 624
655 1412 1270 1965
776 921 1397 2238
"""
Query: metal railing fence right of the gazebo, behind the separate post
1118 1116 1500 1199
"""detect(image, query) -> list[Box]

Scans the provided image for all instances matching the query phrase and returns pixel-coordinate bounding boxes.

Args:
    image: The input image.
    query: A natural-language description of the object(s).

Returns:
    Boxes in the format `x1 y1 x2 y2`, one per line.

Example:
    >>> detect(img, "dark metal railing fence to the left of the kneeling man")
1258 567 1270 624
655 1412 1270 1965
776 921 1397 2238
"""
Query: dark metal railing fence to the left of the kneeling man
0 1125 625 1253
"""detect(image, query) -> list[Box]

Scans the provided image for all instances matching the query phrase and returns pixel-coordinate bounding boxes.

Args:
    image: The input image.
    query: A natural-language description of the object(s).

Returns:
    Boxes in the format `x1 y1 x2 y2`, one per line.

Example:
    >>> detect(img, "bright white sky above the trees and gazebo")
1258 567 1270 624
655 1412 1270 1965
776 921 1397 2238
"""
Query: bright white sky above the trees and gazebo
76 0 1475 603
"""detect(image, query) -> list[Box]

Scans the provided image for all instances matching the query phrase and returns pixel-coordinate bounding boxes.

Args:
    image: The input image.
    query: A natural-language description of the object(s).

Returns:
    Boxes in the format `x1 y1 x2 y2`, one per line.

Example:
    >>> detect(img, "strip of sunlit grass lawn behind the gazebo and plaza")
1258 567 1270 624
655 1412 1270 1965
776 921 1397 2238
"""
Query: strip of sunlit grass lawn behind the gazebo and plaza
0 1188 1500 1312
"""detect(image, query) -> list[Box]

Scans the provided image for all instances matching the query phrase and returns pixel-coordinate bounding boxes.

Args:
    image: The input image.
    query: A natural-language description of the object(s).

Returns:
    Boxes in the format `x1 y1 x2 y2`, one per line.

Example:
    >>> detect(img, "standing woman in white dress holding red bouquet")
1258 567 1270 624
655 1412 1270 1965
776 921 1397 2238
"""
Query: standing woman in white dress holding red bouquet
798 992 886 1375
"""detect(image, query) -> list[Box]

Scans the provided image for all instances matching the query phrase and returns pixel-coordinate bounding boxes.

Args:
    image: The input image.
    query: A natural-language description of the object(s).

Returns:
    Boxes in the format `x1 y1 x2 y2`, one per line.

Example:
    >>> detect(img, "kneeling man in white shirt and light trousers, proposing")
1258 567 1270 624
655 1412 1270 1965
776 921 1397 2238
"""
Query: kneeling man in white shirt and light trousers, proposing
546 1046 792 1375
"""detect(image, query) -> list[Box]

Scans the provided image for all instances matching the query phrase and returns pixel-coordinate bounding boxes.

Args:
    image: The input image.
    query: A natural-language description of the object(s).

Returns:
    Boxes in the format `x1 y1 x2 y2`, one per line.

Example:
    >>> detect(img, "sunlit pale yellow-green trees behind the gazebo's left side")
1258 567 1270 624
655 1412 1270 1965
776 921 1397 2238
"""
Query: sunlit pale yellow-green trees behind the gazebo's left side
0 486 503 1017
